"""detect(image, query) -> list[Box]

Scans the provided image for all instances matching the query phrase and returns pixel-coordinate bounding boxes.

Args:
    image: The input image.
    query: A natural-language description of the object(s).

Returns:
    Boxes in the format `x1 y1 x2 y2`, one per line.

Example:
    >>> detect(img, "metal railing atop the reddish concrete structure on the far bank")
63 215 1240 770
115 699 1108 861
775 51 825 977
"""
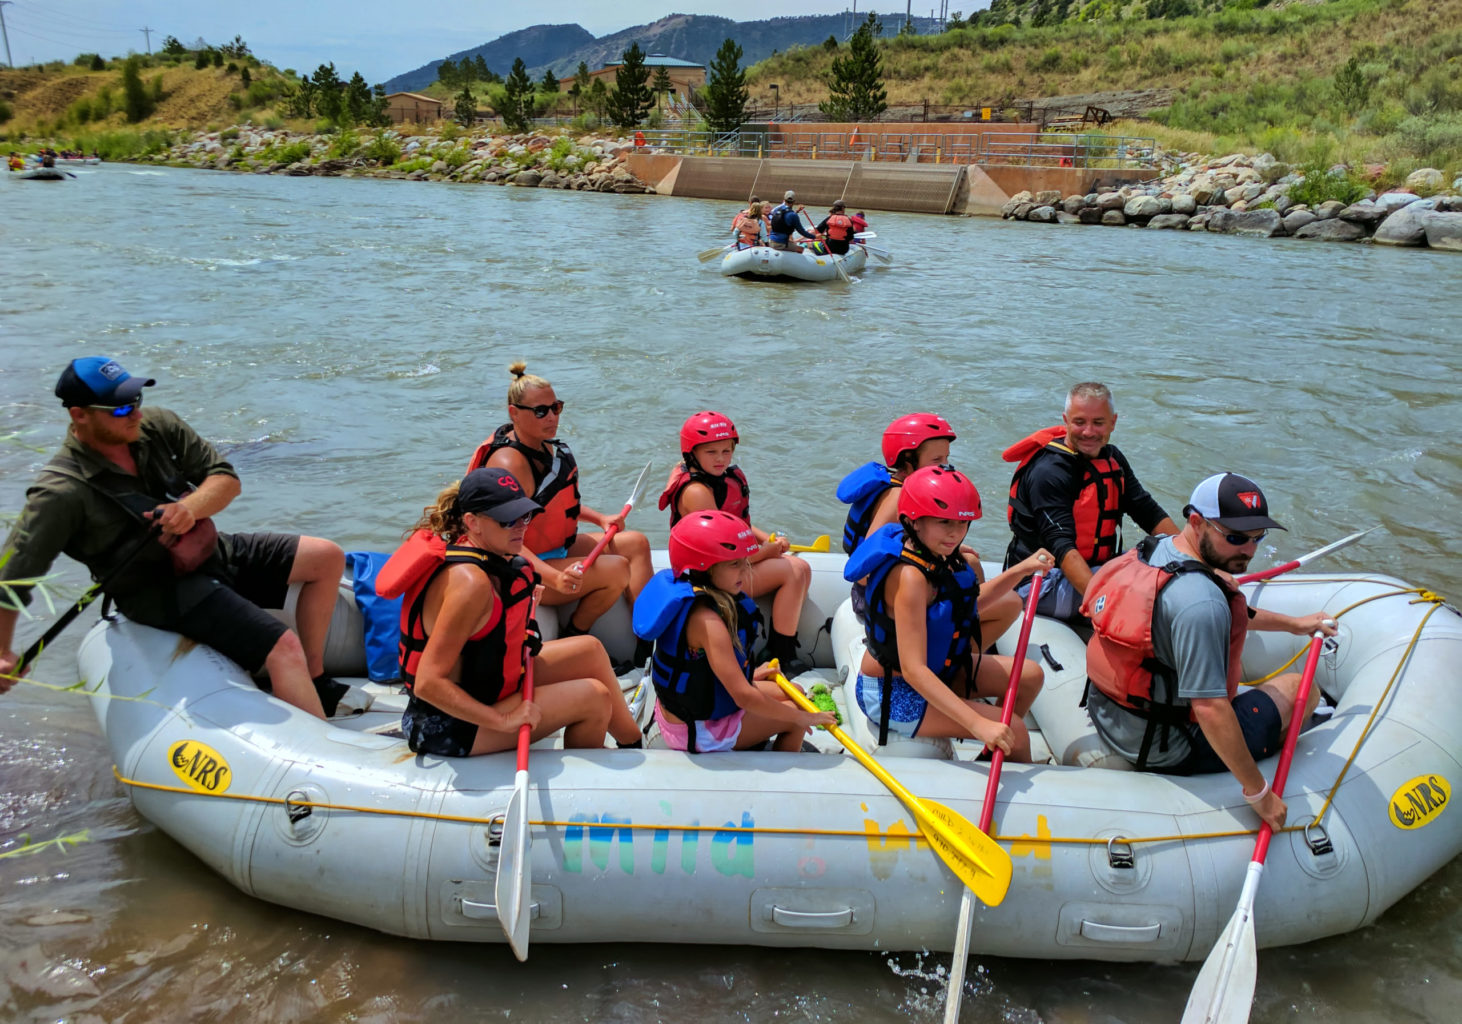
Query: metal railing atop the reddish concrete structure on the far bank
642 124 1156 170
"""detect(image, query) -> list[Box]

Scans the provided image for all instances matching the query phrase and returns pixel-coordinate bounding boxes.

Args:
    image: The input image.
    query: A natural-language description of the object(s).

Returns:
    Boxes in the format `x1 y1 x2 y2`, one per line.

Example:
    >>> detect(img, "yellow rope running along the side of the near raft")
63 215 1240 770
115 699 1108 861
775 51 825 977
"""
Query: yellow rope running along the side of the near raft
111 581 1444 846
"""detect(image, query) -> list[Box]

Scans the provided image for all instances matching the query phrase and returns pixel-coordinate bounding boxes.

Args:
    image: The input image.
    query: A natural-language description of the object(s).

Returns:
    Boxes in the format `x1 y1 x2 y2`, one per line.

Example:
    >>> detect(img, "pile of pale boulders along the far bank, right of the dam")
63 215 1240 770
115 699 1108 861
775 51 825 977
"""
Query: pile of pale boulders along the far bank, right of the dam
1000 154 1462 252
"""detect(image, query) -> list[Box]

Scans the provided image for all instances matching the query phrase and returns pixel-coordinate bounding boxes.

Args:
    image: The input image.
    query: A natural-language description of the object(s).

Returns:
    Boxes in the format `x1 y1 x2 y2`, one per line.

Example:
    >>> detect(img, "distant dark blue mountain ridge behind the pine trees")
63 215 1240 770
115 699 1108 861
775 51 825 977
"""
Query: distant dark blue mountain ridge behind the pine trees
386 10 937 92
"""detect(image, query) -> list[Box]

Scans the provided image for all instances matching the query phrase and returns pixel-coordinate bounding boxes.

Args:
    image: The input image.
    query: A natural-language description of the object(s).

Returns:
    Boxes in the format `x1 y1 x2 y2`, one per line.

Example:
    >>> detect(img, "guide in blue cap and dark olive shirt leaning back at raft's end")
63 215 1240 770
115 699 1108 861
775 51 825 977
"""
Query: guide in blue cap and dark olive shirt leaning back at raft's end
0 355 353 718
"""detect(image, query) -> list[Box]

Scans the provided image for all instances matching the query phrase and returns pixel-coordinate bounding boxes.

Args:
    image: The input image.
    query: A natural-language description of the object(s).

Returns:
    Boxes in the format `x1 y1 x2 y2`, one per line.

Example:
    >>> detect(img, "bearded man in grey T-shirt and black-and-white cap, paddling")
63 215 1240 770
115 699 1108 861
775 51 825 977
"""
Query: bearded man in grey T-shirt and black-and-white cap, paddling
1082 473 1335 831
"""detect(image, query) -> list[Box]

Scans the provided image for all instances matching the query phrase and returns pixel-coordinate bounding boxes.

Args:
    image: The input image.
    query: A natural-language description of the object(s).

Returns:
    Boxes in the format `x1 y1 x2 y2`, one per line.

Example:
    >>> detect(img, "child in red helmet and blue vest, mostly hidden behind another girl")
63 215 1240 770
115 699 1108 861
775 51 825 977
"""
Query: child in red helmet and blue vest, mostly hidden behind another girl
838 413 1020 642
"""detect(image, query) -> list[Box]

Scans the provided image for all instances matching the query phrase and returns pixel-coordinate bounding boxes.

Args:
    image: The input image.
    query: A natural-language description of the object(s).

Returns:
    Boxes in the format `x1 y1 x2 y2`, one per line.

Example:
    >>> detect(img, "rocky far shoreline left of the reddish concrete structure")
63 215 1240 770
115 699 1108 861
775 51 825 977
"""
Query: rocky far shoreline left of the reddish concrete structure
136 124 654 193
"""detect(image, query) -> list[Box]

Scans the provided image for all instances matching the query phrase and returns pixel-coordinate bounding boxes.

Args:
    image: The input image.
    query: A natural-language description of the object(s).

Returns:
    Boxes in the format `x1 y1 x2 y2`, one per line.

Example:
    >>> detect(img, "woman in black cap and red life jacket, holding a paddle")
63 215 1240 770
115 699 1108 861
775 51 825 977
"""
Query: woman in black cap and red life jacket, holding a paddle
376 468 640 758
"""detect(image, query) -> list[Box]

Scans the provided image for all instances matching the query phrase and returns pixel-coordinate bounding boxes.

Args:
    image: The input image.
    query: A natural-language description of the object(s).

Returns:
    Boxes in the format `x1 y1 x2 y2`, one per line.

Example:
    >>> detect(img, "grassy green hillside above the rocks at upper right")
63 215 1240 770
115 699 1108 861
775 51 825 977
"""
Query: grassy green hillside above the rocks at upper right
749 0 1462 173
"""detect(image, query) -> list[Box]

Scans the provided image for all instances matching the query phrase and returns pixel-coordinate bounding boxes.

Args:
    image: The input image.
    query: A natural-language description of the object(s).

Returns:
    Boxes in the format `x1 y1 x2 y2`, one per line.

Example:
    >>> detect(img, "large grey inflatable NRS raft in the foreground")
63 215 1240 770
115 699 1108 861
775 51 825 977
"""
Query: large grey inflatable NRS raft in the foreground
79 553 1462 961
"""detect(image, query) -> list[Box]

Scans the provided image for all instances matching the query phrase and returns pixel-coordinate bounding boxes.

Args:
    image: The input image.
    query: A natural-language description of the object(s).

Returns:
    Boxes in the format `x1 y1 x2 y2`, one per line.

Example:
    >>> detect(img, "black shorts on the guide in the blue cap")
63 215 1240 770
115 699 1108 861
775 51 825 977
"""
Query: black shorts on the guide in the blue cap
128 534 300 673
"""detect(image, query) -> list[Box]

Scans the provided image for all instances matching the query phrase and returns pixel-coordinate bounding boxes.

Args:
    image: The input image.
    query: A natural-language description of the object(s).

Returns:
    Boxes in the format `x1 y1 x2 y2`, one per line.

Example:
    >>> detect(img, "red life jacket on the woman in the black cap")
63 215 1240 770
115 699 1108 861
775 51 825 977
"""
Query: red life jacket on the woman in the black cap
376 530 538 705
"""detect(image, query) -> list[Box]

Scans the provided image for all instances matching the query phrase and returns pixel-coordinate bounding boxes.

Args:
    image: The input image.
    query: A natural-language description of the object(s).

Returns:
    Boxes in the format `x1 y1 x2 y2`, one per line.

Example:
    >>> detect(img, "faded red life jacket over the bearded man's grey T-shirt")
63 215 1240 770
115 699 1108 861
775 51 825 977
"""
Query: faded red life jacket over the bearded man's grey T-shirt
1082 537 1249 771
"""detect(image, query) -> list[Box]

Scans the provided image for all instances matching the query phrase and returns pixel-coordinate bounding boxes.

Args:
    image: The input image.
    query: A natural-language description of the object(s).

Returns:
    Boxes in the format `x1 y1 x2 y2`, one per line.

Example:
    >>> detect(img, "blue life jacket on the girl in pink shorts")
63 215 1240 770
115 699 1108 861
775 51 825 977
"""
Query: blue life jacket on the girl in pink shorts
633 569 762 753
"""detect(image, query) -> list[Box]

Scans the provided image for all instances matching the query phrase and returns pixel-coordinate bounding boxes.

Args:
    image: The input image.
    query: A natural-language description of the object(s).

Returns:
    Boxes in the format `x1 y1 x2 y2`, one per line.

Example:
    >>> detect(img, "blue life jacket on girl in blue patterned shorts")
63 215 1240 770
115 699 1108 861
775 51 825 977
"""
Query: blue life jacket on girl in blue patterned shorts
842 522 984 745
